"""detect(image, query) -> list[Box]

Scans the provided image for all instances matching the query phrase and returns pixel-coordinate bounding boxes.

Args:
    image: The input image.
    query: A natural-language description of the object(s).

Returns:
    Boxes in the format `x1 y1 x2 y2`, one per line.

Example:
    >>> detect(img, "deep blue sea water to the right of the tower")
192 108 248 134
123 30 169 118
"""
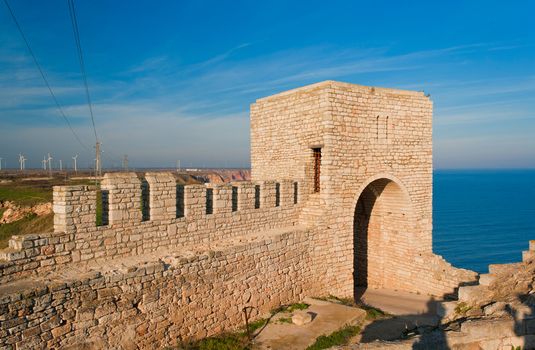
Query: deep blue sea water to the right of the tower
433 170 535 273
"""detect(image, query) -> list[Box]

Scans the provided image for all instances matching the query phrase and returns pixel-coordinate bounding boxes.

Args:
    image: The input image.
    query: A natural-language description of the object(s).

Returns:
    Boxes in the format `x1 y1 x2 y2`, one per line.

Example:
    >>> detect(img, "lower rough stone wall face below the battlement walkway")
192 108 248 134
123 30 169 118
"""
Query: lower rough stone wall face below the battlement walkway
0 230 322 349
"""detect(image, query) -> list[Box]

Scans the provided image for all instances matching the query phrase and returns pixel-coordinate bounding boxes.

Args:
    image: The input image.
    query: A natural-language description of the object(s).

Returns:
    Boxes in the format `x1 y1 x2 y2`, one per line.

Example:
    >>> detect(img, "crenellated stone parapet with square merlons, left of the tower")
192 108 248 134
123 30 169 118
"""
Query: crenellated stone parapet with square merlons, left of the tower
0 173 300 283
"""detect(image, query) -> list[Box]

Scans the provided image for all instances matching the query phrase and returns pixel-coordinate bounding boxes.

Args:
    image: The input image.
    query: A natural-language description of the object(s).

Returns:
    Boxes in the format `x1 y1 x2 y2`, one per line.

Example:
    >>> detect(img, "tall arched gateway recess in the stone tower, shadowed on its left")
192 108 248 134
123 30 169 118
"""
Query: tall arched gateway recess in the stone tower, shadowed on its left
353 178 414 297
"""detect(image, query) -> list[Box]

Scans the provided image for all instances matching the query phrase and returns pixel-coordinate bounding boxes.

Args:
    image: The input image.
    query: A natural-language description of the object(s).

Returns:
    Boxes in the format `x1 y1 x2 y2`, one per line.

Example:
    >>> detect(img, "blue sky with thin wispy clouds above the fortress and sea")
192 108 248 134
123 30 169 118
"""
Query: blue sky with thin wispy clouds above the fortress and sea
0 0 535 168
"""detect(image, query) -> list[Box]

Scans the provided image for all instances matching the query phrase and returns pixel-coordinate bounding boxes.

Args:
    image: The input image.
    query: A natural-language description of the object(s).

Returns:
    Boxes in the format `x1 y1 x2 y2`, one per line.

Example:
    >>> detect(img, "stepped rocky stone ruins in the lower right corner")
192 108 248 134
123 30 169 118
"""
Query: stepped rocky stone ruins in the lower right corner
338 241 535 350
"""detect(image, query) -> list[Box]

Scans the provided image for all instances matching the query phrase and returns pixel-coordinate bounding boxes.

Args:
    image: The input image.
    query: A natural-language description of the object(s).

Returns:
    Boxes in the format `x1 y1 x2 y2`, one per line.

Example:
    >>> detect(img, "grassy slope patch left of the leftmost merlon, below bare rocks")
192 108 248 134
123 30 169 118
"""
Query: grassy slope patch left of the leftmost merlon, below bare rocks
0 214 54 249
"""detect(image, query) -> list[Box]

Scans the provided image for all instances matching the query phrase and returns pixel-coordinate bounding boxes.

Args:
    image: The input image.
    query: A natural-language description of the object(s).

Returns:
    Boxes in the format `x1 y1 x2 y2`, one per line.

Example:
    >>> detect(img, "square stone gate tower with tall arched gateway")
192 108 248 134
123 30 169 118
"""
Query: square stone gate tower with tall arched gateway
251 81 473 297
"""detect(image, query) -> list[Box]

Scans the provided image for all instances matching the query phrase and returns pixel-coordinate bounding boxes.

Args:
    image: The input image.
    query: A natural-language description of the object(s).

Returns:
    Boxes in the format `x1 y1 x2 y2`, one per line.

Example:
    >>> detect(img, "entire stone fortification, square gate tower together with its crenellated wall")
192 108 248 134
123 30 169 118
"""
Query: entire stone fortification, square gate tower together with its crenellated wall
0 81 475 349
